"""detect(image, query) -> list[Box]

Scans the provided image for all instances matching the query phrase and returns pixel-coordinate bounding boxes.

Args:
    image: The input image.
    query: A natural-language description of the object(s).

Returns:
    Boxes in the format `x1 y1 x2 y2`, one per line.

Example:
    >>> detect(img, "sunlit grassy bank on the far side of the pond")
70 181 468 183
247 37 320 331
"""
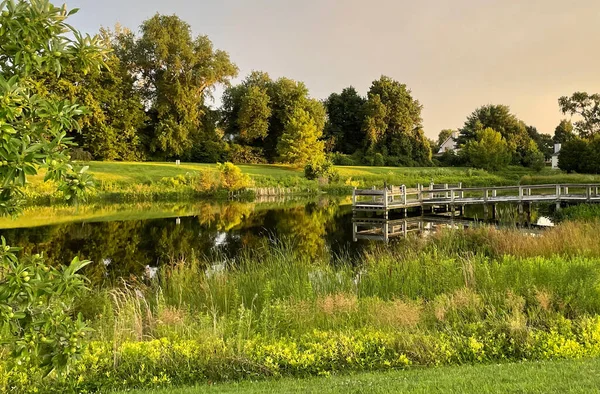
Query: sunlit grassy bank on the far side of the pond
21 162 600 204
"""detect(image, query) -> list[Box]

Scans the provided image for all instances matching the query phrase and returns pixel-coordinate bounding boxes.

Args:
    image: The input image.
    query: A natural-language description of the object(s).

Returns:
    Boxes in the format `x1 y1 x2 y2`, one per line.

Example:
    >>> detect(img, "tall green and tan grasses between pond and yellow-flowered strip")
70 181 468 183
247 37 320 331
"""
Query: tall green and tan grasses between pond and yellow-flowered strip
82 222 600 341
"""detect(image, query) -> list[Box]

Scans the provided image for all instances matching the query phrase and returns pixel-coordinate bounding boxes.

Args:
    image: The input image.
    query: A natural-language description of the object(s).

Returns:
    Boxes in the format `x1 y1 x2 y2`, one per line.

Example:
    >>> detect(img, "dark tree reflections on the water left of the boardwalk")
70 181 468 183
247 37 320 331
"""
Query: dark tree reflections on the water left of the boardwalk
0 199 361 280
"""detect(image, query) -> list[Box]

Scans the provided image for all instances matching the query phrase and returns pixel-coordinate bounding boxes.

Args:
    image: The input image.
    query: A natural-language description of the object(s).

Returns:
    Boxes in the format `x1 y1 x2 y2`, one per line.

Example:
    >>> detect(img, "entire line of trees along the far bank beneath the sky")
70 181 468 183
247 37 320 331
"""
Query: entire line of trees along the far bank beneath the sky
29 14 600 171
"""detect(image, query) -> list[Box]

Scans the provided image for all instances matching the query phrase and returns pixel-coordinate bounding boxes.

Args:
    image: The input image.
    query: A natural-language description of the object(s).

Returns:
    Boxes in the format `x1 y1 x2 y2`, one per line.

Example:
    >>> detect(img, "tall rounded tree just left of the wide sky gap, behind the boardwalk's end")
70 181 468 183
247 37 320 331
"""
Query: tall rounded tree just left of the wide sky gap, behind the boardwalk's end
364 76 431 164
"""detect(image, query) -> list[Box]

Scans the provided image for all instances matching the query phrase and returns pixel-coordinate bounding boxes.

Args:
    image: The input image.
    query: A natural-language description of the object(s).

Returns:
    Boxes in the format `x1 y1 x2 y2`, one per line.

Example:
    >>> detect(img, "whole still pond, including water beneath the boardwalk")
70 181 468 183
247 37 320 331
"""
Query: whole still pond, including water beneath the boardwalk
0 198 551 284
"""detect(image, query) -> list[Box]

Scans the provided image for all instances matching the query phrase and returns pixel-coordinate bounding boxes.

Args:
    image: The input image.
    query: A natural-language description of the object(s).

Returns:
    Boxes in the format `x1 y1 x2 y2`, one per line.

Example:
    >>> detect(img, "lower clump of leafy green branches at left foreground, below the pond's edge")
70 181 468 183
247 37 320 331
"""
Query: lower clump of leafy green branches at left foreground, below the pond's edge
0 238 90 372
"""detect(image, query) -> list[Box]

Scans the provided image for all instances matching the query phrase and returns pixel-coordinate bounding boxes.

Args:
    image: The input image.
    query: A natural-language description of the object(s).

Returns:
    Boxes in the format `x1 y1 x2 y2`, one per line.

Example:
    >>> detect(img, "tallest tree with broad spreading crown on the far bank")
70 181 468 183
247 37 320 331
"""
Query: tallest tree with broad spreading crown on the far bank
115 14 237 157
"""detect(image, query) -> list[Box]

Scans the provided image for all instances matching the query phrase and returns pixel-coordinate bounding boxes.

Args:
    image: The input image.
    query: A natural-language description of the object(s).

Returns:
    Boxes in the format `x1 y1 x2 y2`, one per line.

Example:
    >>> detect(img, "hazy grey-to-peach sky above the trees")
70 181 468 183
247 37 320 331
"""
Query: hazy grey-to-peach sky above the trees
67 0 600 138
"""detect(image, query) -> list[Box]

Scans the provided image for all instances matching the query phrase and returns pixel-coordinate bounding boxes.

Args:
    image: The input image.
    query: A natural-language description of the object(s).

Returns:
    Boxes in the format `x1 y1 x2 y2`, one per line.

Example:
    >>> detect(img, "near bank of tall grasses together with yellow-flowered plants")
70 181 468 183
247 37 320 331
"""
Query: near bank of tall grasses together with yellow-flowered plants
0 221 600 392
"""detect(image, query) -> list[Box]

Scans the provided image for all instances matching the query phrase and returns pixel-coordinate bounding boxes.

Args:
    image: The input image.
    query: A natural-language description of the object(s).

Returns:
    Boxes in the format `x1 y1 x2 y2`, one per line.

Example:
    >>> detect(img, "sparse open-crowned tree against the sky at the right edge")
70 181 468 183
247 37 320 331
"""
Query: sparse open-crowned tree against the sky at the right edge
558 92 600 138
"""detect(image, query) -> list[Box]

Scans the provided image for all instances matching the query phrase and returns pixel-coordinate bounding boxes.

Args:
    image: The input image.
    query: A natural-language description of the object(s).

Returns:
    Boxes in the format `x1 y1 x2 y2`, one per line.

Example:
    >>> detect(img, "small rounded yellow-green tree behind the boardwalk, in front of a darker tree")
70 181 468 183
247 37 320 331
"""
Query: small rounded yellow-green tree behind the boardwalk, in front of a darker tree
461 127 511 171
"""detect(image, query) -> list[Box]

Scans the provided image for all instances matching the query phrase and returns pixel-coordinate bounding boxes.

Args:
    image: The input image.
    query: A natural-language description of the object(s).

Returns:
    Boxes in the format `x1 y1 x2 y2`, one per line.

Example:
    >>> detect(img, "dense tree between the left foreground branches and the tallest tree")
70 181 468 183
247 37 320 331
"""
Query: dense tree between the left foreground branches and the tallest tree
36 30 146 161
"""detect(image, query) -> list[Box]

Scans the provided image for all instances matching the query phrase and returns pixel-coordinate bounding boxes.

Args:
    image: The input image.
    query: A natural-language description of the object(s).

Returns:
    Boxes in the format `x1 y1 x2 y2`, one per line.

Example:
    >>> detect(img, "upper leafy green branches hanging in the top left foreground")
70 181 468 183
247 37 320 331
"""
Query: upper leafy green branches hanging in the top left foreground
0 1 105 215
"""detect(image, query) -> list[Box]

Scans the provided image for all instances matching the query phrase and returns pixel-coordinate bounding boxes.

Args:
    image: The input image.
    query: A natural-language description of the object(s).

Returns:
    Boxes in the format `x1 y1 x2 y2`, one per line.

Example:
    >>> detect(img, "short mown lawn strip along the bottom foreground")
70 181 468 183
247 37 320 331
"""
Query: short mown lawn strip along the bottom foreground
115 358 600 394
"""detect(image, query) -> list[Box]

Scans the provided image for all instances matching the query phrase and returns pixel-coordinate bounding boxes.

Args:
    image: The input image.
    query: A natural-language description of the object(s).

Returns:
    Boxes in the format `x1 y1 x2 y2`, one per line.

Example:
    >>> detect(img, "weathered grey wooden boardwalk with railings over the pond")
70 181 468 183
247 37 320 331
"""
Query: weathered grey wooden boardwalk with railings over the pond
352 183 600 213
